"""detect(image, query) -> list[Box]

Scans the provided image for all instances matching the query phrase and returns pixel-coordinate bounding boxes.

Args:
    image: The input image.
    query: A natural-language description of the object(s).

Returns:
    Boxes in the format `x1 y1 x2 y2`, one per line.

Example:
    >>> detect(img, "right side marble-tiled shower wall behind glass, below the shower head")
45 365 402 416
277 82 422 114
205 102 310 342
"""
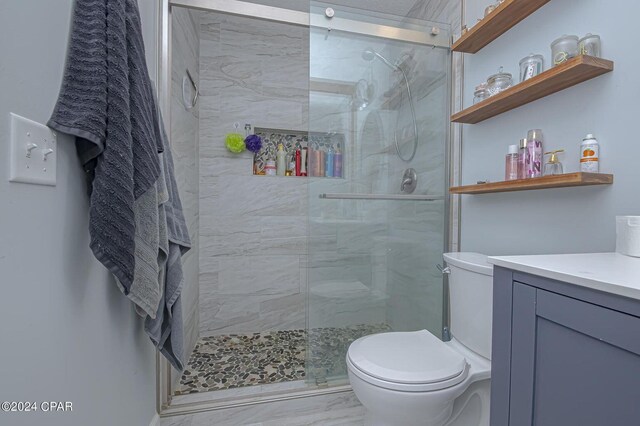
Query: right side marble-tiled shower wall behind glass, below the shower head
380 0 461 335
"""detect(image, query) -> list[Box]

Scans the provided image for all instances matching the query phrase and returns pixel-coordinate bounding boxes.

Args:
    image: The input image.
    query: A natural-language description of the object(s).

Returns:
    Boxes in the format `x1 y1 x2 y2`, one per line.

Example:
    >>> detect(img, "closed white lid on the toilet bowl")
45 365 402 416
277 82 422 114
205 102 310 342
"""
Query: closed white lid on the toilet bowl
348 330 466 384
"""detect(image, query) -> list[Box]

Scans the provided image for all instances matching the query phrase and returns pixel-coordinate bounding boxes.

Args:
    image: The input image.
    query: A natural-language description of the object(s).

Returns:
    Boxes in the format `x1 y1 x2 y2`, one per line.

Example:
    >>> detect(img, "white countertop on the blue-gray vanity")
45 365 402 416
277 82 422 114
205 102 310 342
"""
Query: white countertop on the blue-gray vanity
488 253 640 300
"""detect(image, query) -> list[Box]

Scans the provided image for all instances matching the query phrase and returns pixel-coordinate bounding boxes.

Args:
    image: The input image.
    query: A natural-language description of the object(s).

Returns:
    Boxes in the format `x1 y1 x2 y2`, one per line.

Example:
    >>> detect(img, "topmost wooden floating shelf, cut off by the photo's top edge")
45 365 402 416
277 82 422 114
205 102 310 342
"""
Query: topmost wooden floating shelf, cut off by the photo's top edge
452 0 549 53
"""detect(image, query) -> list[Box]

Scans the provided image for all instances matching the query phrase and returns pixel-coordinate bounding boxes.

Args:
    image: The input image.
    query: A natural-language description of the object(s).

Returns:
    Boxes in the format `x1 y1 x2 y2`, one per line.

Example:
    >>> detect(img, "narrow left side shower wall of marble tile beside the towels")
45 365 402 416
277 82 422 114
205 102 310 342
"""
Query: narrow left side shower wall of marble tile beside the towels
171 8 200 380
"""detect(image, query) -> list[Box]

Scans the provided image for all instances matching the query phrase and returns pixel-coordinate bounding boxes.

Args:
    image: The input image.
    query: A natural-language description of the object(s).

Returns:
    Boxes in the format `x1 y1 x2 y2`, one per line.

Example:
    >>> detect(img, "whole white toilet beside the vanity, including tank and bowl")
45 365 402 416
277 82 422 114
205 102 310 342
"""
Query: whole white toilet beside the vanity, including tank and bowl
347 253 493 426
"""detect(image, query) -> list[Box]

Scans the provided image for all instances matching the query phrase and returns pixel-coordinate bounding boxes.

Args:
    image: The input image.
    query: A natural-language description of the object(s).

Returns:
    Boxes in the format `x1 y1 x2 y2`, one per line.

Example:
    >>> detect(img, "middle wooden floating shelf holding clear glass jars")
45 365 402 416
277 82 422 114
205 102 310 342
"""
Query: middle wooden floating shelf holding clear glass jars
451 55 613 124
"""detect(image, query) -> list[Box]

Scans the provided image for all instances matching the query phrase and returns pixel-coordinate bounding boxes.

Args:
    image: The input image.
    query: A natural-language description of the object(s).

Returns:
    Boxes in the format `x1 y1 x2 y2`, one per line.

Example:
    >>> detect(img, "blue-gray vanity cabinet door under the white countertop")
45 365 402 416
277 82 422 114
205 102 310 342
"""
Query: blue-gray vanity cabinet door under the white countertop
509 283 640 426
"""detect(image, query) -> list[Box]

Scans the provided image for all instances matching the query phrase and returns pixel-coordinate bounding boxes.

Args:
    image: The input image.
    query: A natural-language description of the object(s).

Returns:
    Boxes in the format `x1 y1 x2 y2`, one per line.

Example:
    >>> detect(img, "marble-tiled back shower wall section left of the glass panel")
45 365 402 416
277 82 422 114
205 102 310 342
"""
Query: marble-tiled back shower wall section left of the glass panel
199 13 309 336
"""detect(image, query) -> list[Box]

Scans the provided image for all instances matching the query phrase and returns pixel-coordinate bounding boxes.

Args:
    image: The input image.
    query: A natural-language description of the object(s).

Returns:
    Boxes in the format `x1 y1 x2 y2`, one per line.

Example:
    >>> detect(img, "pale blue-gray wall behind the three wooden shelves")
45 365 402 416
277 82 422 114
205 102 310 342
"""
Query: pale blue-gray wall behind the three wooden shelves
461 0 640 255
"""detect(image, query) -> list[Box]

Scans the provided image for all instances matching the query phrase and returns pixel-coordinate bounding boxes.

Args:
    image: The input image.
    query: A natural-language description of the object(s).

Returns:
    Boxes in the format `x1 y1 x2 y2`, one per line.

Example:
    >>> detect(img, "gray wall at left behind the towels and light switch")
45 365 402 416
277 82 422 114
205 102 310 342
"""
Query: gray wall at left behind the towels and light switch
0 0 155 426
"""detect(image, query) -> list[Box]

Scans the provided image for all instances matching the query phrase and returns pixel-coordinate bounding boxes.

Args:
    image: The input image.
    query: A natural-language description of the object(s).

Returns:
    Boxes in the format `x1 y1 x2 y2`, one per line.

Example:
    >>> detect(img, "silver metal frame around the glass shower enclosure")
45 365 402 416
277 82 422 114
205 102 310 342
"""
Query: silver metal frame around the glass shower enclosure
155 0 459 417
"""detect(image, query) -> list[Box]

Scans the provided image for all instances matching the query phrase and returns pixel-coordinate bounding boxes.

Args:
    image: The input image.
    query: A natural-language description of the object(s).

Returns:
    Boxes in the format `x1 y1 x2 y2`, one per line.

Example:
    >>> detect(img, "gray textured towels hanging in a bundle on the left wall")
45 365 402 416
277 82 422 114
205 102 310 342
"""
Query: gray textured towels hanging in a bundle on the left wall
48 0 190 370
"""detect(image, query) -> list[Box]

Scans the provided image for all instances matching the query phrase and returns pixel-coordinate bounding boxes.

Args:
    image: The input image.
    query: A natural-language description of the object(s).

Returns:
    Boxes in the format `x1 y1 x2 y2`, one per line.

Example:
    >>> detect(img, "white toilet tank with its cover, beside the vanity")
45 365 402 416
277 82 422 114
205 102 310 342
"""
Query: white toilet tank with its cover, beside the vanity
443 252 493 359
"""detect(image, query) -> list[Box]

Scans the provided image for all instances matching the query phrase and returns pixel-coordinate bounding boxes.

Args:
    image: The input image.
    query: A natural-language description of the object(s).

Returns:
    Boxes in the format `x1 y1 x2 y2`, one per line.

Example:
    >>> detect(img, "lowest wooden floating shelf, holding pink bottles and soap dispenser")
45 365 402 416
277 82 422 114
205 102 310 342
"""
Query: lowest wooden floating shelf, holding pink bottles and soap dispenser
449 172 613 194
